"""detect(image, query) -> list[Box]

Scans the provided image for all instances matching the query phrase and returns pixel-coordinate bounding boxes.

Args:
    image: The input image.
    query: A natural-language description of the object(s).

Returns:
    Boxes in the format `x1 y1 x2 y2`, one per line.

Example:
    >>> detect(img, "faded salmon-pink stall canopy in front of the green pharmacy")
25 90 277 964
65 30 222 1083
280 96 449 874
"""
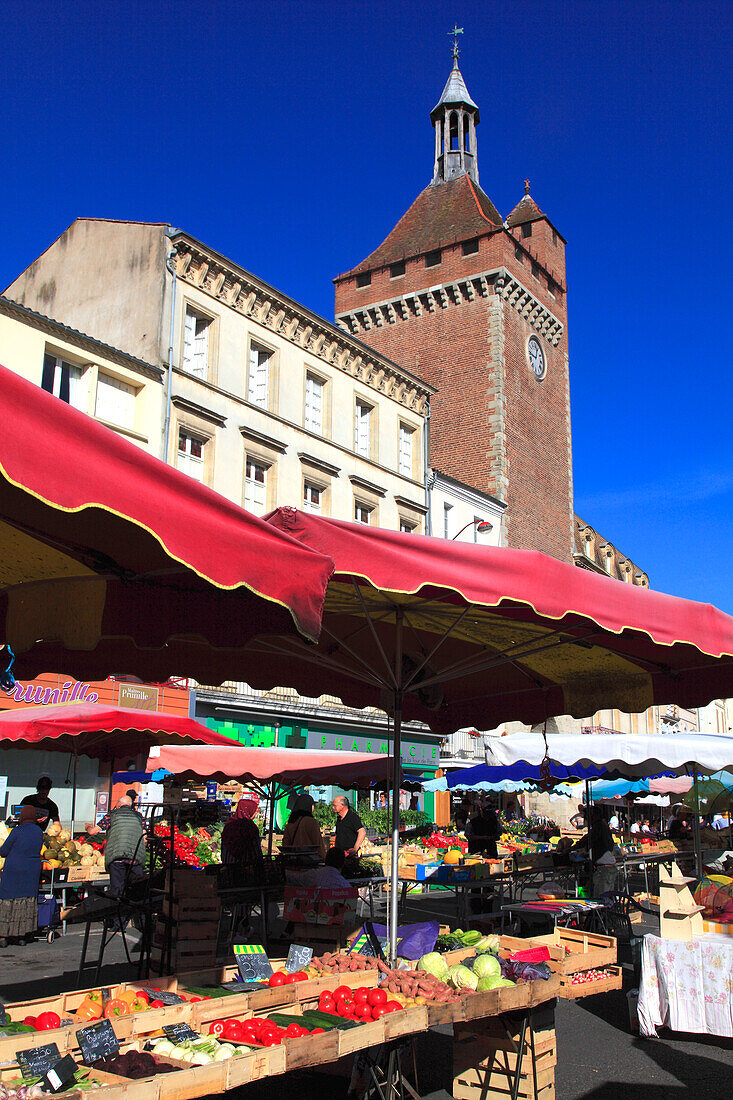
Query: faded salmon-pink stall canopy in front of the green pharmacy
147 741 392 789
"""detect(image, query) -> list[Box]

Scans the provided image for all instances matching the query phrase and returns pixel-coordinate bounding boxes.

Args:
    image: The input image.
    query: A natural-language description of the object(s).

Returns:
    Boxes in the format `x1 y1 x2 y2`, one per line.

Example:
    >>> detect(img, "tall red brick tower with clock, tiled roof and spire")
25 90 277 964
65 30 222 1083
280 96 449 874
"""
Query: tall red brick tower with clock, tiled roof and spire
335 47 573 561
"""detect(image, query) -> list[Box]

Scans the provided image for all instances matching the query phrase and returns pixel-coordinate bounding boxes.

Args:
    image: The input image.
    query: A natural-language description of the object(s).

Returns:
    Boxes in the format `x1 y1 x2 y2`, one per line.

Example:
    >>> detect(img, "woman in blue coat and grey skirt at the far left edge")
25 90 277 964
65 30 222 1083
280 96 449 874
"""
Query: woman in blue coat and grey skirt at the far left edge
0 805 43 947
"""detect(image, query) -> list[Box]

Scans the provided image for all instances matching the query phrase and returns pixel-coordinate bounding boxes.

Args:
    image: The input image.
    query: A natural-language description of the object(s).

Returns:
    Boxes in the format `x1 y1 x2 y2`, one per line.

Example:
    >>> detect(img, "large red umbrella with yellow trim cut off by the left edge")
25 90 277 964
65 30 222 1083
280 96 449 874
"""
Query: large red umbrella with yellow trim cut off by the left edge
0 367 332 683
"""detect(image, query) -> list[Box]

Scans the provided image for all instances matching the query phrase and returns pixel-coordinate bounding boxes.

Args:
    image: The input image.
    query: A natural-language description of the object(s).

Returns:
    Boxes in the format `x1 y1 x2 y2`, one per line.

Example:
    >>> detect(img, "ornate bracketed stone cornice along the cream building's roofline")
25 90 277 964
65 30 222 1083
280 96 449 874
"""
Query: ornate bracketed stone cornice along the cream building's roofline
173 233 435 416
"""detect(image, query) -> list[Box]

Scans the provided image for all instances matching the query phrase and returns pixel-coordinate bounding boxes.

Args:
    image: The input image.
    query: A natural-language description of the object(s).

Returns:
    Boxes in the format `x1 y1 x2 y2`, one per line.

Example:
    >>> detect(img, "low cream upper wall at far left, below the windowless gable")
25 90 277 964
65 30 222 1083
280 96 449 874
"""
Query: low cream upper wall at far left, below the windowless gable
0 306 164 458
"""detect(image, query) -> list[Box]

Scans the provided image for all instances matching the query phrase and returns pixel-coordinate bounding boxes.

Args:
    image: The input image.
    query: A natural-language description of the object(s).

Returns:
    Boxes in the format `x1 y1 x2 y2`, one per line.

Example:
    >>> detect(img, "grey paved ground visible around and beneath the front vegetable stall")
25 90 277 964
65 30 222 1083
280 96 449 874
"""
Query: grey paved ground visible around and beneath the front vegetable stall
0 931 733 1100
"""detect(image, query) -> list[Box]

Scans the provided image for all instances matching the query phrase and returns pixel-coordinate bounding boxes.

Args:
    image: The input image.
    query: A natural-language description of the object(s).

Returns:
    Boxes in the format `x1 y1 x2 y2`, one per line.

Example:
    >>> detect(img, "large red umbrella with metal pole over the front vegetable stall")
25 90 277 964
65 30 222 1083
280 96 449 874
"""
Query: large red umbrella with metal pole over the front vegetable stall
264 508 733 948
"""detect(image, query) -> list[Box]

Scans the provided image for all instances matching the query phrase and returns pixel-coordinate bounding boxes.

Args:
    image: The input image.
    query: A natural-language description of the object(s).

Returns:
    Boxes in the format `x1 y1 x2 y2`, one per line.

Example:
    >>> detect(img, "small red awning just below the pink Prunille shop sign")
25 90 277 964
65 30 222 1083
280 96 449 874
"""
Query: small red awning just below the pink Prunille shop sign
0 703 231 760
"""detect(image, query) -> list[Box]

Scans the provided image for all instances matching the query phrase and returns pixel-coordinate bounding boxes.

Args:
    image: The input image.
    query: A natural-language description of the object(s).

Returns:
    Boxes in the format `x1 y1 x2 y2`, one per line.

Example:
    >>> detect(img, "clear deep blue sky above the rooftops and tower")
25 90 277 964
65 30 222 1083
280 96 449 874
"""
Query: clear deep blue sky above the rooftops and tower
0 0 733 613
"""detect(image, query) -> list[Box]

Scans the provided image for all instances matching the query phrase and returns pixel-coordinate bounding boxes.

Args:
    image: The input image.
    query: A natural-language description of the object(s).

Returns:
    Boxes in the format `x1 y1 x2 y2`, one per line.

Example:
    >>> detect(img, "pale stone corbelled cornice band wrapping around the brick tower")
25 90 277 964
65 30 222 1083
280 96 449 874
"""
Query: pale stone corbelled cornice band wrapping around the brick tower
337 267 565 347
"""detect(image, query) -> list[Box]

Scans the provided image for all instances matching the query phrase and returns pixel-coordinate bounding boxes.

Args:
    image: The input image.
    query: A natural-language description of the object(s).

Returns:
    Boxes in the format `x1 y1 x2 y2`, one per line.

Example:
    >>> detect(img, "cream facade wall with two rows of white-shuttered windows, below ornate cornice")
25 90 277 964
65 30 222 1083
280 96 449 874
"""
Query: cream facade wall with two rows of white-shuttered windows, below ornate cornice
168 279 425 531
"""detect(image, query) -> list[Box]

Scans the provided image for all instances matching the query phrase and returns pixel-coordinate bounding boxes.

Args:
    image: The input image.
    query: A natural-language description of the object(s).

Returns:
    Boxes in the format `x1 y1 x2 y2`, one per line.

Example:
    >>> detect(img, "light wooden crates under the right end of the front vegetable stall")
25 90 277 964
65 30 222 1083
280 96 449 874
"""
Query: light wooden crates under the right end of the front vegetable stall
452 1021 557 1100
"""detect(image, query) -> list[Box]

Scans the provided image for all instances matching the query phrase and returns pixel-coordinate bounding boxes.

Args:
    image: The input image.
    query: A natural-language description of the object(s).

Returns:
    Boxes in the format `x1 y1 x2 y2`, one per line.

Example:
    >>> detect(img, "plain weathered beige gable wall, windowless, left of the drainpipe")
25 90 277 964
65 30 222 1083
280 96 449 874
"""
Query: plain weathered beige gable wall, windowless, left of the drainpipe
4 218 168 365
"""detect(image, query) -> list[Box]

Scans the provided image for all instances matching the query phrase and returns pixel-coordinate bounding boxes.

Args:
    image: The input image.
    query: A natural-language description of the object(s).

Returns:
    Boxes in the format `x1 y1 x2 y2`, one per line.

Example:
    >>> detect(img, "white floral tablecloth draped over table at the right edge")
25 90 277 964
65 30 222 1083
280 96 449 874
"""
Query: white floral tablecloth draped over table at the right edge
638 935 733 1038
